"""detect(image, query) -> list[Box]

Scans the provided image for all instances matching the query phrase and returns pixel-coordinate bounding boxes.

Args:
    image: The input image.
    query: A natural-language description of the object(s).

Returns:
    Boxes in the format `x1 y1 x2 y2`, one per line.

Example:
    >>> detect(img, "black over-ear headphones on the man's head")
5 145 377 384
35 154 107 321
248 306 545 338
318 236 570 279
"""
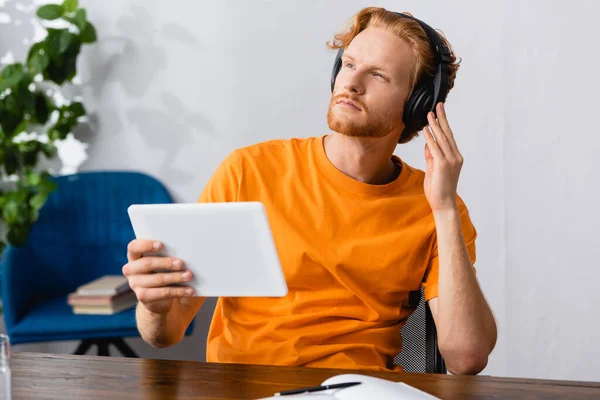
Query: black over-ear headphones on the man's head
331 12 451 142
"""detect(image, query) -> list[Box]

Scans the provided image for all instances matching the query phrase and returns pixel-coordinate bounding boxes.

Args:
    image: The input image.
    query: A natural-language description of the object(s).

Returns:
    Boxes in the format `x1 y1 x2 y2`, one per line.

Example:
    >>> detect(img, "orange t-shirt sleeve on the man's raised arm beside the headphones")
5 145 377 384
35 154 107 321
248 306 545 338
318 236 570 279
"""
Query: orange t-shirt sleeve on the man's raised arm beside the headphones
422 198 477 301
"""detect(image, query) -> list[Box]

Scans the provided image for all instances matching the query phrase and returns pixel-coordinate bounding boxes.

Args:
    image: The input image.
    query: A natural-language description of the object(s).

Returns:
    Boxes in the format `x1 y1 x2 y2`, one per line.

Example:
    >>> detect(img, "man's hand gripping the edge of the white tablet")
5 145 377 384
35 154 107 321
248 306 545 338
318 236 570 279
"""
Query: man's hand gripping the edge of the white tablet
123 239 194 314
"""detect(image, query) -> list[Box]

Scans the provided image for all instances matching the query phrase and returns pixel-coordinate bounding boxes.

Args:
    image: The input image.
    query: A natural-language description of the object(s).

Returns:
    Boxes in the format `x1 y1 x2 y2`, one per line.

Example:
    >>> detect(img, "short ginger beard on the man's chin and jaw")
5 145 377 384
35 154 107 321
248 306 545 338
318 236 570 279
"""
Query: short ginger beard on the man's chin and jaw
327 94 402 138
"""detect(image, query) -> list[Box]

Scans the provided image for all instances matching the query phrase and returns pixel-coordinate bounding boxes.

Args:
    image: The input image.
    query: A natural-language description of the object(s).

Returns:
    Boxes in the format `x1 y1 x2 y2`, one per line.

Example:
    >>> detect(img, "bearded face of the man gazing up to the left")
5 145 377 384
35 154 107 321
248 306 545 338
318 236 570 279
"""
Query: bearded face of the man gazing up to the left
327 27 414 137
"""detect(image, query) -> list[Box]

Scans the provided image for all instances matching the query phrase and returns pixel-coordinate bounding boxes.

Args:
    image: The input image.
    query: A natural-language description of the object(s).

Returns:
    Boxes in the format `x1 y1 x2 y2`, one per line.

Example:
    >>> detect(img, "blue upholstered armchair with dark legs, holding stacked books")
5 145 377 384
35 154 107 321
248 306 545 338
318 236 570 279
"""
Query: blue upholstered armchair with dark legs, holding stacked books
0 172 193 357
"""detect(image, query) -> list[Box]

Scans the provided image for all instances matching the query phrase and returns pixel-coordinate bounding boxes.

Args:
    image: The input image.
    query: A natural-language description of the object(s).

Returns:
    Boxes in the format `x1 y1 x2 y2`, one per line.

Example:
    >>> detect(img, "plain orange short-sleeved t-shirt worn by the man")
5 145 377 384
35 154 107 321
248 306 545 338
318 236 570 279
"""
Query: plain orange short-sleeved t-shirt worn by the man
199 137 477 370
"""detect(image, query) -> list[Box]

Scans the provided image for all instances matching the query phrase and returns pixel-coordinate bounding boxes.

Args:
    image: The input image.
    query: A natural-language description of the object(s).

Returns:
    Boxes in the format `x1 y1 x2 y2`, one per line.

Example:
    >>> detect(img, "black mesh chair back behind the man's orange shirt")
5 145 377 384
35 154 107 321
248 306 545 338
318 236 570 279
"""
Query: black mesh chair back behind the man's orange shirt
394 288 447 374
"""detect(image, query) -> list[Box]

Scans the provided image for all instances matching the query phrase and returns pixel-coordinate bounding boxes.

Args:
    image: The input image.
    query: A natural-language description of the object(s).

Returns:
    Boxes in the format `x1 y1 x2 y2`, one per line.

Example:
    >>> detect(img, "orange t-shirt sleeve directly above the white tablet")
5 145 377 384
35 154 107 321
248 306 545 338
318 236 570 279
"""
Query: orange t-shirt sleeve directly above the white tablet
198 151 242 203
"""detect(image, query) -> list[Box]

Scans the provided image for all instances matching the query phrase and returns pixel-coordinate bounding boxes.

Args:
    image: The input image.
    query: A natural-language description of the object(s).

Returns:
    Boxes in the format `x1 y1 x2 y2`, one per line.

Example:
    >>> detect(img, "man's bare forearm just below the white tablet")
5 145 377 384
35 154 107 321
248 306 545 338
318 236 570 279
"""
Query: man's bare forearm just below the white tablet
136 298 204 348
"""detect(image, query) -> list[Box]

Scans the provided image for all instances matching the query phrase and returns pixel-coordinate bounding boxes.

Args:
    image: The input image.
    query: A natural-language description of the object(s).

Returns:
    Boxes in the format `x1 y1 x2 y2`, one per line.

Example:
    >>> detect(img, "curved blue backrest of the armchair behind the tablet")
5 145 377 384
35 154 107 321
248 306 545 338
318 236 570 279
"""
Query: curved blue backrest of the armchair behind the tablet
11 171 172 302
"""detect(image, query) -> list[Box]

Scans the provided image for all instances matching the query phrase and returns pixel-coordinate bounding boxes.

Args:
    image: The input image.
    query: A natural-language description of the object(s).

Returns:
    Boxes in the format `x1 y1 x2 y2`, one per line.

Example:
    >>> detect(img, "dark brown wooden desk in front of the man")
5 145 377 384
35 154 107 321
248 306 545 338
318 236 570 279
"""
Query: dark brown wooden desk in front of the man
11 353 600 400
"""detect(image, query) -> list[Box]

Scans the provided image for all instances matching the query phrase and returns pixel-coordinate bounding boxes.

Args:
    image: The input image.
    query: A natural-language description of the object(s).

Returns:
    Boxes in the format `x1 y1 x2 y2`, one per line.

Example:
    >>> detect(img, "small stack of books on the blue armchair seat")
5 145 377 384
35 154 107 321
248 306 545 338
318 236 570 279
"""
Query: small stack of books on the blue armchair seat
67 275 137 315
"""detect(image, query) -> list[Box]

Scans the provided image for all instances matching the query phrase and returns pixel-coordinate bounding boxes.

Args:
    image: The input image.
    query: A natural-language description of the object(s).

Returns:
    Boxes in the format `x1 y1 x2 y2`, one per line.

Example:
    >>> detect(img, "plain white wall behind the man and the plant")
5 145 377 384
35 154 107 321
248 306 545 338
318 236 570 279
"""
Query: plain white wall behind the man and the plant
0 0 600 381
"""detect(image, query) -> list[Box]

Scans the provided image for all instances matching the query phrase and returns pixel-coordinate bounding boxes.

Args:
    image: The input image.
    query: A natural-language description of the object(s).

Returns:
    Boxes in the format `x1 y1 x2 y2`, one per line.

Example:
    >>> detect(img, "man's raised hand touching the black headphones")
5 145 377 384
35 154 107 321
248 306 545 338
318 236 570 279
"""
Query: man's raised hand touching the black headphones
423 103 463 213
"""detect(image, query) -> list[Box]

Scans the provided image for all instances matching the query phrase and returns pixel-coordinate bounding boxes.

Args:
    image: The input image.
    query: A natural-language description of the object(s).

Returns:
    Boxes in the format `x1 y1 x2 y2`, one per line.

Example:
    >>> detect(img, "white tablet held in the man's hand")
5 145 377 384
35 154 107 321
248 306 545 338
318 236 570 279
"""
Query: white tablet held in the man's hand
127 202 288 297
